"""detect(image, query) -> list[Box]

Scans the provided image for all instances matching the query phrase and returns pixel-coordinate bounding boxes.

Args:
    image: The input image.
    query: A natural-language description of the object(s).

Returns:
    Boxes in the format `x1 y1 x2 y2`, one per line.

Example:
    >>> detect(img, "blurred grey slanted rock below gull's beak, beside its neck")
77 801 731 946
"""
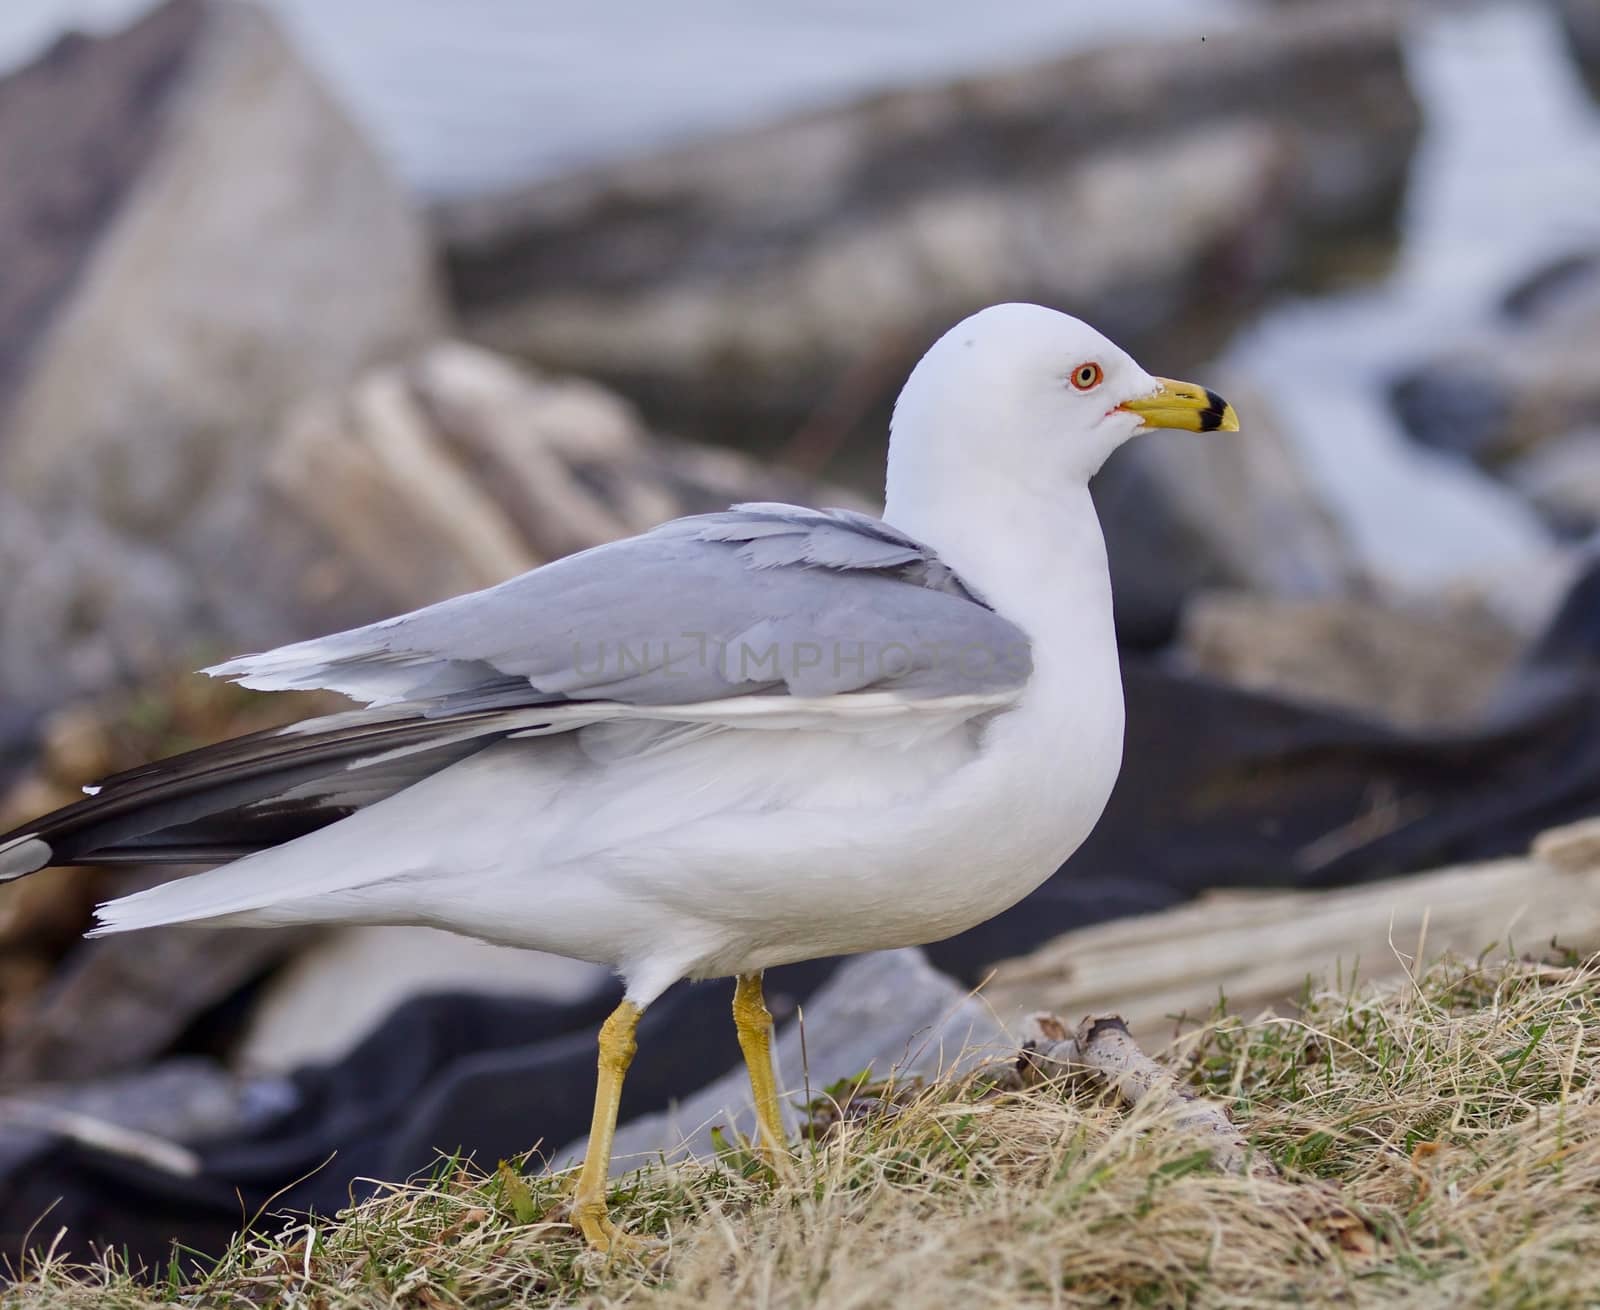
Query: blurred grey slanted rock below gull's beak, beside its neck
1093 377 1358 648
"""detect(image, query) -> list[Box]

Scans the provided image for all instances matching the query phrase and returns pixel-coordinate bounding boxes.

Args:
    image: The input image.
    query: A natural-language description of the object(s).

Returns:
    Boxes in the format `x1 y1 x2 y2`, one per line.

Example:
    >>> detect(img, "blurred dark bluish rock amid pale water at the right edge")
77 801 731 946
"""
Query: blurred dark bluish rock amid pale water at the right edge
1392 253 1600 465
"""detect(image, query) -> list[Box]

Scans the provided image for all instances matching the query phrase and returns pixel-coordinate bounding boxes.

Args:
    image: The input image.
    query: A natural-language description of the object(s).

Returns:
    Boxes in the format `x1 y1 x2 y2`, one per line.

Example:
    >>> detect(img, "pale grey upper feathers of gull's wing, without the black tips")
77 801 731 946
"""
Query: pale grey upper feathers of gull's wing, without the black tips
206 504 1032 713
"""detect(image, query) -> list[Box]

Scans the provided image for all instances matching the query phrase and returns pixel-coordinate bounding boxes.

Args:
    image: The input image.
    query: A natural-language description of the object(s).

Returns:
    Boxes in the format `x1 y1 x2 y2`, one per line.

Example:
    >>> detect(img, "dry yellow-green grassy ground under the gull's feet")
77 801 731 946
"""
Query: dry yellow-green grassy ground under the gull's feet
0 960 1600 1310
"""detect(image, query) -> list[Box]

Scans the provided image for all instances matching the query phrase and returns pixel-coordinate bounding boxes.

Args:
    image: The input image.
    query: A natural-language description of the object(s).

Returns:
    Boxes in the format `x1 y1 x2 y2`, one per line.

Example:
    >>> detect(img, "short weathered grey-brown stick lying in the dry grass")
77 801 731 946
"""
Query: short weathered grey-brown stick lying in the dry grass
1018 1011 1277 1177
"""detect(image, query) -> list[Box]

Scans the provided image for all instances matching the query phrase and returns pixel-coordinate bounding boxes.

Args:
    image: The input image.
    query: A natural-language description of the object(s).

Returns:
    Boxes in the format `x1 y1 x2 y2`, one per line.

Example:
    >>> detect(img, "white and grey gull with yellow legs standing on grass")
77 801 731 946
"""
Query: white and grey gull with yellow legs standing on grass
0 304 1238 1251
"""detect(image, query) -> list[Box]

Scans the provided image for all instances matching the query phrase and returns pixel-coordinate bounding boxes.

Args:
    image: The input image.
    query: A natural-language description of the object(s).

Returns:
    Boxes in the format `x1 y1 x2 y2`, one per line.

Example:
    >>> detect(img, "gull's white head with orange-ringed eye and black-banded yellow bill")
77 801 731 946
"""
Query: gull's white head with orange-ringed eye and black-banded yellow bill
890 304 1238 496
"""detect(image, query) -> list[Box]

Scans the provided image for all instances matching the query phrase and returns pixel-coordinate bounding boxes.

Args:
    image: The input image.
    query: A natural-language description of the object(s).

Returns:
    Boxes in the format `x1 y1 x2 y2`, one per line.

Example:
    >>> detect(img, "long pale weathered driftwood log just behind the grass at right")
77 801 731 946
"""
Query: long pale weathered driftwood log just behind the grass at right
982 825 1600 1032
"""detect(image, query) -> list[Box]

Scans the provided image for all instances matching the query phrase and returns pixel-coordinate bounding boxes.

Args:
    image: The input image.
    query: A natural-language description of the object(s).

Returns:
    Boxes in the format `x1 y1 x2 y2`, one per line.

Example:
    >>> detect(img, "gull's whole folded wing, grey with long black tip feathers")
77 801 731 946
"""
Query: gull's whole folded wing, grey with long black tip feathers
0 504 1032 881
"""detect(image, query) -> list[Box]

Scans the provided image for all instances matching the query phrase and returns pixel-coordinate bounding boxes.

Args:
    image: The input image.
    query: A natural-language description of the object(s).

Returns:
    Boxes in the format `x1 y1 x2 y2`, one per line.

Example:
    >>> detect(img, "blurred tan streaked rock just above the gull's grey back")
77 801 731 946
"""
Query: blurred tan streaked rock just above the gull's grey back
237 342 851 633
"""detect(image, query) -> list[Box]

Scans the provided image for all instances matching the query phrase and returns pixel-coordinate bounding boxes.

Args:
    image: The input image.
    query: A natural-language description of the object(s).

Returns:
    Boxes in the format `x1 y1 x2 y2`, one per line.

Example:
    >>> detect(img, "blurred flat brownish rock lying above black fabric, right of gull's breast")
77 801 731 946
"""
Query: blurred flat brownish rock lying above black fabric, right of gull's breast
1179 592 1522 731
